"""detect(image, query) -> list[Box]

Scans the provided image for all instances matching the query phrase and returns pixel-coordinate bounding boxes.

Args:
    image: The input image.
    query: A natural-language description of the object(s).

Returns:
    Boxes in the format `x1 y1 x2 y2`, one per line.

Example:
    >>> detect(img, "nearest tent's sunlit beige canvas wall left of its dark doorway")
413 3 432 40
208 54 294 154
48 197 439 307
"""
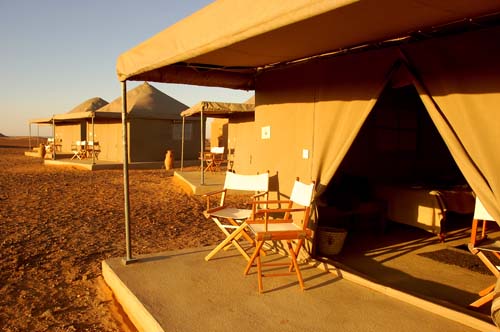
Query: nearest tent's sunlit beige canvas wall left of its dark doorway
249 50 397 196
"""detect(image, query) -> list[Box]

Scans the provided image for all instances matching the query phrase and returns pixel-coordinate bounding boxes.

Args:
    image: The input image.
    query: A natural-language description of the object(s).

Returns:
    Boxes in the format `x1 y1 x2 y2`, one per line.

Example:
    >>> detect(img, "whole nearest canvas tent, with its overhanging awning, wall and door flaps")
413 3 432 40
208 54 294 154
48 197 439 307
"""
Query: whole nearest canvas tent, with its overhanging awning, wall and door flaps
117 0 500 228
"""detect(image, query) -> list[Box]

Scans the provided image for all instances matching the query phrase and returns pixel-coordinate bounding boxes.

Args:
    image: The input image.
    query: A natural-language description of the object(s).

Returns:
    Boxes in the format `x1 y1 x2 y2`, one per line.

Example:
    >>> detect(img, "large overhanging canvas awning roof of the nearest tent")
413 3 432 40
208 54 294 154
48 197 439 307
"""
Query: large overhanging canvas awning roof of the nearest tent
117 0 500 90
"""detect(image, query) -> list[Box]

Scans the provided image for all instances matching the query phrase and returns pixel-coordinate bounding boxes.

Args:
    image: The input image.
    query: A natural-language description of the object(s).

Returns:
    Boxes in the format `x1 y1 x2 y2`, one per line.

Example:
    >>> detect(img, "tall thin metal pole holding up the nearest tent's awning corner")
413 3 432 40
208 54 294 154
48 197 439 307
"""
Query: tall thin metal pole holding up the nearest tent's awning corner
121 81 133 264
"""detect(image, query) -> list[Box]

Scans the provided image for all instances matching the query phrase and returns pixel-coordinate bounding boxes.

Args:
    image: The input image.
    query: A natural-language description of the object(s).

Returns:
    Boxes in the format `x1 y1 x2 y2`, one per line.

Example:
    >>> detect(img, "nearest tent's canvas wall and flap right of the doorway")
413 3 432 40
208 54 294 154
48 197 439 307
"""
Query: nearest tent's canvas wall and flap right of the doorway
407 28 500 221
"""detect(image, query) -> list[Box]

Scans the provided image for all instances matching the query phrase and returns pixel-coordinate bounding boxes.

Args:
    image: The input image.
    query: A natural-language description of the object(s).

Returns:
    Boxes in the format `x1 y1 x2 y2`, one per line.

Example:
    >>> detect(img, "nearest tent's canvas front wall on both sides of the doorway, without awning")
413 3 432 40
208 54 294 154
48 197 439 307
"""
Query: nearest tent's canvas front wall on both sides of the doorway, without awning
249 28 500 220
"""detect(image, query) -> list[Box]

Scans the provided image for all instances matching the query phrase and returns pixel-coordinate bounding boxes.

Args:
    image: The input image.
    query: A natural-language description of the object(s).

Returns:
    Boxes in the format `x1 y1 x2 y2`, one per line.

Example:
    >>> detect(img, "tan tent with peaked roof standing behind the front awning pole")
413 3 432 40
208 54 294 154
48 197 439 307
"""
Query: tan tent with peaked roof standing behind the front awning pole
95 82 196 162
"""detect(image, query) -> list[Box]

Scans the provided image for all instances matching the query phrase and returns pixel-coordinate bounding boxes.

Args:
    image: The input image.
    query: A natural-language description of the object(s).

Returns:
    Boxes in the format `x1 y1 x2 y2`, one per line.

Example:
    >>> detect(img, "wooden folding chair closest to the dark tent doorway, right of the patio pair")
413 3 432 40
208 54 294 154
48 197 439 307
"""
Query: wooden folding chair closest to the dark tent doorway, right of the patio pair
244 178 314 293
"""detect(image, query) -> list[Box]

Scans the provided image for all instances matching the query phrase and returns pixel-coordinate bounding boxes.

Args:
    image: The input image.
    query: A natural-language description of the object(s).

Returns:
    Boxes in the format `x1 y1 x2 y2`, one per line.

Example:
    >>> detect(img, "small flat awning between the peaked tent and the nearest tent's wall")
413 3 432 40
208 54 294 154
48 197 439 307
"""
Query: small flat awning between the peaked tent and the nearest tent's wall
181 101 255 118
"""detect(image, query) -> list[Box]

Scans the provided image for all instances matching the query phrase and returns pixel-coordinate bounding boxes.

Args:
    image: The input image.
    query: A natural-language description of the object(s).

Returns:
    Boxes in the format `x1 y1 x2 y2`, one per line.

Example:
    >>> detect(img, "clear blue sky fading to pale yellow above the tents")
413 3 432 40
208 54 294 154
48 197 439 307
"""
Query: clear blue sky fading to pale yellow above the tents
0 0 253 136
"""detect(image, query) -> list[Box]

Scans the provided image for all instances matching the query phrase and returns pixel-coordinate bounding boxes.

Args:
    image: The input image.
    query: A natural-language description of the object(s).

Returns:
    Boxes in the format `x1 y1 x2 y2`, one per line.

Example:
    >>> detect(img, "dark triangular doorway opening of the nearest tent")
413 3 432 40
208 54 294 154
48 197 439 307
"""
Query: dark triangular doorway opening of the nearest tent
318 85 474 239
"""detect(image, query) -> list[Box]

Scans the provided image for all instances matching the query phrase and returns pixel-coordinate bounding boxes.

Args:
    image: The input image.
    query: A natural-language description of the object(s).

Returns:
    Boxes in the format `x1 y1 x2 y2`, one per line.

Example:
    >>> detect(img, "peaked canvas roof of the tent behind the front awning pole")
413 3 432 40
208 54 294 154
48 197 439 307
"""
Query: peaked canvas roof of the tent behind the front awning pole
95 82 188 119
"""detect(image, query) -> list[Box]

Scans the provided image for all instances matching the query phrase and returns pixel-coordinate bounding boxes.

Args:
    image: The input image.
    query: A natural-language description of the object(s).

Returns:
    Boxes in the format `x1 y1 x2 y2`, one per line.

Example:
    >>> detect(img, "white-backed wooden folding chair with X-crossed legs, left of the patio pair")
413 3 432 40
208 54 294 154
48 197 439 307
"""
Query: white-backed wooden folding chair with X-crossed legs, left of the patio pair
203 172 269 261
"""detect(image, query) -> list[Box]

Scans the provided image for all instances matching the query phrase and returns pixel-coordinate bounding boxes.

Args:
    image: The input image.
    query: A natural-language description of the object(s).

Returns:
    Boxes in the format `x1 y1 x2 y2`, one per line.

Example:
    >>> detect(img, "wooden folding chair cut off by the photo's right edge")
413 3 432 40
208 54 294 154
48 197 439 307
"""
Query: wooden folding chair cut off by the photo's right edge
468 197 500 308
